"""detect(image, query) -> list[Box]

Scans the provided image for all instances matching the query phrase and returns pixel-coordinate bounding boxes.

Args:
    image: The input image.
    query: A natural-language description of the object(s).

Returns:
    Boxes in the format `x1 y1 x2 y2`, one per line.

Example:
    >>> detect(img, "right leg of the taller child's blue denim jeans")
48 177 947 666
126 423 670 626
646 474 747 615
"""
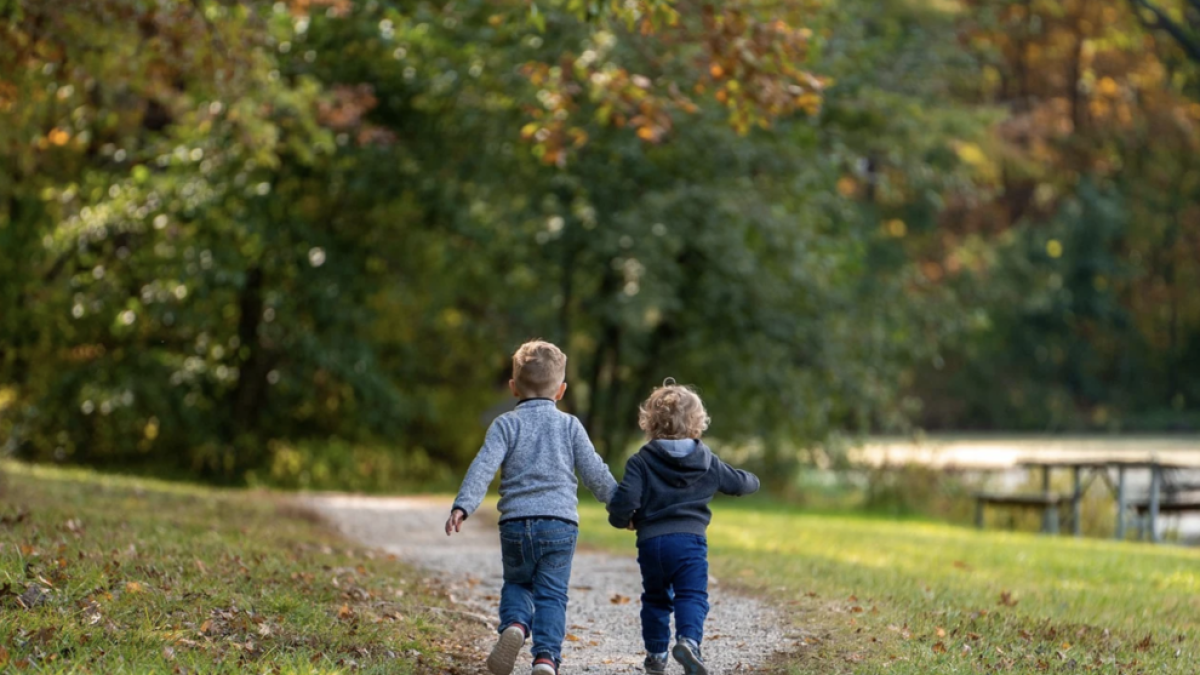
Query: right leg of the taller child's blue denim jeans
533 520 580 663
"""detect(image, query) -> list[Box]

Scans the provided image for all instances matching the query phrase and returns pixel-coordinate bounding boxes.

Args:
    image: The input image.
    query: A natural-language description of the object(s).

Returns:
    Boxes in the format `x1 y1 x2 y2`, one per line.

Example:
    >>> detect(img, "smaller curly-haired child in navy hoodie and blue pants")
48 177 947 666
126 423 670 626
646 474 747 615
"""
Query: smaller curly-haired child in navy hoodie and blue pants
608 378 758 675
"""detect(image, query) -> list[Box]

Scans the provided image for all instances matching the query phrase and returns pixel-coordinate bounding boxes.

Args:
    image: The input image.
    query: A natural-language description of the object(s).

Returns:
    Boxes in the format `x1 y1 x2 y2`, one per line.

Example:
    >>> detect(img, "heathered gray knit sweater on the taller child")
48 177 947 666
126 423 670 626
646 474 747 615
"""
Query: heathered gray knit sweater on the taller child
454 399 617 524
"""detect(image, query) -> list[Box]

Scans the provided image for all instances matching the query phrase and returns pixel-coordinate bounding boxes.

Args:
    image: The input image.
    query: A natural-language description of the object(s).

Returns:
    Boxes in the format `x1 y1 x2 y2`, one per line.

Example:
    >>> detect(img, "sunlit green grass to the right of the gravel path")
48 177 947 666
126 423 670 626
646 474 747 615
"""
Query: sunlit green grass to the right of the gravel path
582 500 1200 675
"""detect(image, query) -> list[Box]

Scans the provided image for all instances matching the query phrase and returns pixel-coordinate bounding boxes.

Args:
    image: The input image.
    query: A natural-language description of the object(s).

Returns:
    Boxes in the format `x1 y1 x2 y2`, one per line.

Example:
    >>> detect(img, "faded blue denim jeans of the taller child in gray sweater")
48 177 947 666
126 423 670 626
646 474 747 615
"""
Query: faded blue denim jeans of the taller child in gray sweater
500 518 580 664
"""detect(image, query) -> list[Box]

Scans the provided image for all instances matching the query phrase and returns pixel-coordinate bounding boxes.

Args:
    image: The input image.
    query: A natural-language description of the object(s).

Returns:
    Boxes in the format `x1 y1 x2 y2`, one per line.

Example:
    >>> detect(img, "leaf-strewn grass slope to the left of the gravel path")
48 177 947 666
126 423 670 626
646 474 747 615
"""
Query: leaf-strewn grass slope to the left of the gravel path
0 464 473 674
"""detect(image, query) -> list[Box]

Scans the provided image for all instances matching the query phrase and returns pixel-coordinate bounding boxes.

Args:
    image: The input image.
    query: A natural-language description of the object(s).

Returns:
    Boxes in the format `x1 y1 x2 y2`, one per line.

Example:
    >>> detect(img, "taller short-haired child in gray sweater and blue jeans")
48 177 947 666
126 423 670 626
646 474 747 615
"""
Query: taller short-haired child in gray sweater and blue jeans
446 340 617 675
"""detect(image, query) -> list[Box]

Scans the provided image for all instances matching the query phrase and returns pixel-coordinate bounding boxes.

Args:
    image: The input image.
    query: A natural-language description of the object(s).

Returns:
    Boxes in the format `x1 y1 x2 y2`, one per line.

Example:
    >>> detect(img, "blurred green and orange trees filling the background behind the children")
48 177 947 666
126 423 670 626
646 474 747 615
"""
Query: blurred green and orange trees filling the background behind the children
0 0 1200 489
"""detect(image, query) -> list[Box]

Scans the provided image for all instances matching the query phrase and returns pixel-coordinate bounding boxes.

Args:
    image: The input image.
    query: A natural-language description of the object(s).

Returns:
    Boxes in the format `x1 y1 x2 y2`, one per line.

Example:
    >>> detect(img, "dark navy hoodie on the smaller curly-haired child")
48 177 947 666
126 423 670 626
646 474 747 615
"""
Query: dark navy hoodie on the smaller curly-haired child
608 441 758 542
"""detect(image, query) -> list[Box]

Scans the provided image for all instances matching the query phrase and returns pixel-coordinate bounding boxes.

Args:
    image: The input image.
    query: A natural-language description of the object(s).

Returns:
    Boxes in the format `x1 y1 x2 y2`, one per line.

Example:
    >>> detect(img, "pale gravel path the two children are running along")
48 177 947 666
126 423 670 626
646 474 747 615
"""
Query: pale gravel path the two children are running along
308 496 793 675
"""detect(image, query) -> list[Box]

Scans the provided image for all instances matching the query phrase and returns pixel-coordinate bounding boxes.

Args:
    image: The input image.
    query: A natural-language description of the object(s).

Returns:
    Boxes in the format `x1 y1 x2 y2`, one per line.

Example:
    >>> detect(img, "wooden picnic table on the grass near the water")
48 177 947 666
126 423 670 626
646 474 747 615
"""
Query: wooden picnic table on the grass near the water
1019 458 1200 542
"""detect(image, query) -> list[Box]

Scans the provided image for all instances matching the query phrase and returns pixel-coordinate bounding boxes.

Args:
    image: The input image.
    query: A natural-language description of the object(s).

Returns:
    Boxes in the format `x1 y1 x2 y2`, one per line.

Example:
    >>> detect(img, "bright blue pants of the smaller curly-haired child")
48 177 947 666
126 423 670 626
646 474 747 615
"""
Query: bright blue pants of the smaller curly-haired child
637 533 708 653
